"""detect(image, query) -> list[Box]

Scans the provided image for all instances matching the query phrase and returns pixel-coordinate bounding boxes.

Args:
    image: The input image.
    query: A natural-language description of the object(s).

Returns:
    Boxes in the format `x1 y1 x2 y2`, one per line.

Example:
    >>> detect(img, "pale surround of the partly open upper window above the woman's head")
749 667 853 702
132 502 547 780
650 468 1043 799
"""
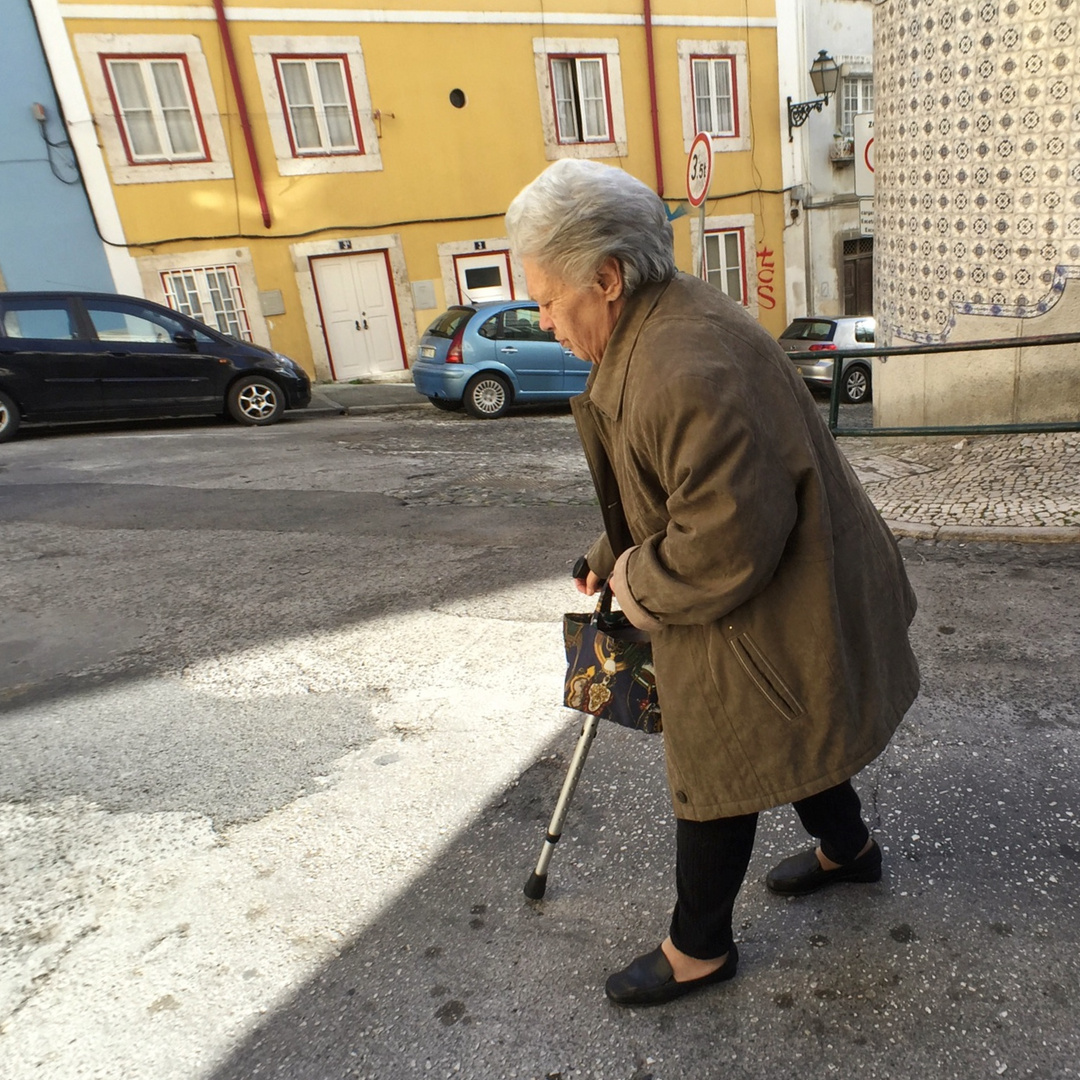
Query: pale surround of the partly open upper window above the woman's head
532 38 627 161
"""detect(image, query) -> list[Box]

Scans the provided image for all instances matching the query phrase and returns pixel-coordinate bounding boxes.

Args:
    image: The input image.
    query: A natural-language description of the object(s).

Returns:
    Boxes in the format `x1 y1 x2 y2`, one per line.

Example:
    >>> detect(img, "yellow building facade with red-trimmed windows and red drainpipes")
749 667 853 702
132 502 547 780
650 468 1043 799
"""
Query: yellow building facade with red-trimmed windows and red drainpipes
46 0 786 381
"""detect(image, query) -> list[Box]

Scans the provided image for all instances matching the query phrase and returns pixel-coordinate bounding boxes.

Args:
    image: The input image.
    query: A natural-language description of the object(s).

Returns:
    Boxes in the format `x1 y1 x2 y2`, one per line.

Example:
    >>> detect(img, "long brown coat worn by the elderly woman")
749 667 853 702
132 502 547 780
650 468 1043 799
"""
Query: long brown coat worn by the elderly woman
571 274 919 821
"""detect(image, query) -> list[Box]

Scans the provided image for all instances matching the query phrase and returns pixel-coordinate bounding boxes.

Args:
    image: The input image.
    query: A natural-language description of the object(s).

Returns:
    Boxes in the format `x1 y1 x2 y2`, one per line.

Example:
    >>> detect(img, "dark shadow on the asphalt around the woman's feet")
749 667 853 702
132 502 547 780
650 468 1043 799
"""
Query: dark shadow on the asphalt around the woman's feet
204 545 1080 1080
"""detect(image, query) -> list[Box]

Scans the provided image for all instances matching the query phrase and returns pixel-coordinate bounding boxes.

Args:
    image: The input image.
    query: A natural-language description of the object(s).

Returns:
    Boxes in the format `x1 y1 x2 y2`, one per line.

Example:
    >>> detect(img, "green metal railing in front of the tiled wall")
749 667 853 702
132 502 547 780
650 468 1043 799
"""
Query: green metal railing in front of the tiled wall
787 334 1080 437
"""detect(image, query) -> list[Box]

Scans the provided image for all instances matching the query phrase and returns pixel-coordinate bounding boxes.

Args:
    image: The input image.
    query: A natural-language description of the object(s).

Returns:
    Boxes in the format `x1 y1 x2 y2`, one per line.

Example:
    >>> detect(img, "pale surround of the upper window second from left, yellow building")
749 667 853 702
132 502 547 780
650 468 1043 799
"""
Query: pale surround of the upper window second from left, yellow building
251 35 382 176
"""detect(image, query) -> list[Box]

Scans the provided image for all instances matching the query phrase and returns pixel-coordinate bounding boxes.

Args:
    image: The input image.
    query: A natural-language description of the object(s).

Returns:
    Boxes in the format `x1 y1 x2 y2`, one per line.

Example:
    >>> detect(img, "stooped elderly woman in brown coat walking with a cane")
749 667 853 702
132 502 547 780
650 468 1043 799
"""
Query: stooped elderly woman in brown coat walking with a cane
507 160 919 1005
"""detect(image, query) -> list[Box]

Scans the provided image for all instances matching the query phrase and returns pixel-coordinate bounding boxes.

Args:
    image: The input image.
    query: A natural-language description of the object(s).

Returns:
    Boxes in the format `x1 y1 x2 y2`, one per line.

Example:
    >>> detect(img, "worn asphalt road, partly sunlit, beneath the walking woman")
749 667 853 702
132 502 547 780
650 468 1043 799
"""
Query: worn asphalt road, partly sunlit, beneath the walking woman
0 409 1080 1080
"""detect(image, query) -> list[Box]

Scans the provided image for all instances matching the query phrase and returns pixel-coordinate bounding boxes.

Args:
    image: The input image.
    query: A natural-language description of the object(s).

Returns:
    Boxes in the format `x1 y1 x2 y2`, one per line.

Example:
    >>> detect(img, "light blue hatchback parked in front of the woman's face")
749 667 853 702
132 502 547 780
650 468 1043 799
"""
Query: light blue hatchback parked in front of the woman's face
413 300 592 420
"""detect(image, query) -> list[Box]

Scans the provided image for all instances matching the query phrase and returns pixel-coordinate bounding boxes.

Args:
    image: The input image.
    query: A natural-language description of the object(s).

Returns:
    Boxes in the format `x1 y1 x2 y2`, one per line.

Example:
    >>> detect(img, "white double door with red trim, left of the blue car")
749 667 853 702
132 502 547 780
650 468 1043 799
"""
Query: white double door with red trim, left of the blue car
311 252 405 382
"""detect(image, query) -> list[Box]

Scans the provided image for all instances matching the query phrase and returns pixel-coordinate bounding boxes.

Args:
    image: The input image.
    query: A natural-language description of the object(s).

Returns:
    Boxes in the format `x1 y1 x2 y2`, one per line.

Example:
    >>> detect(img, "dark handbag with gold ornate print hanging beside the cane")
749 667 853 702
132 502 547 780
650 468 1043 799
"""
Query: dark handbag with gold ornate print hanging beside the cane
563 585 662 733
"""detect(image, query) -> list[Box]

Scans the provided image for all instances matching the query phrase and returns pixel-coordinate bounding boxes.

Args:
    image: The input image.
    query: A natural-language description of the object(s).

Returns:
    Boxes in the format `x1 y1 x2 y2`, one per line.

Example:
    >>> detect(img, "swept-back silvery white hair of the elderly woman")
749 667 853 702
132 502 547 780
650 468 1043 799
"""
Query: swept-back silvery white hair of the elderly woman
507 158 675 296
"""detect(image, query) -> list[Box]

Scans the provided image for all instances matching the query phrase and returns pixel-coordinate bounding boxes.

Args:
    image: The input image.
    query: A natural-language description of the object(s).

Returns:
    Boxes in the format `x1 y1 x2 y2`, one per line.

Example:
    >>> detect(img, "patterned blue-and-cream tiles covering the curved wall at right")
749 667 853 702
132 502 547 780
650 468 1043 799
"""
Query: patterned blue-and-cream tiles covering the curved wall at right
874 0 1080 342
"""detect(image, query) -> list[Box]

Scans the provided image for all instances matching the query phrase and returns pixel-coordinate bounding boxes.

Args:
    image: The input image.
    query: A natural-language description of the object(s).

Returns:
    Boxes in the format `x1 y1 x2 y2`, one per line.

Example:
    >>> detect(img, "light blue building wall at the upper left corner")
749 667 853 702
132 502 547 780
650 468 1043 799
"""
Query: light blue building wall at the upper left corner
0 0 116 293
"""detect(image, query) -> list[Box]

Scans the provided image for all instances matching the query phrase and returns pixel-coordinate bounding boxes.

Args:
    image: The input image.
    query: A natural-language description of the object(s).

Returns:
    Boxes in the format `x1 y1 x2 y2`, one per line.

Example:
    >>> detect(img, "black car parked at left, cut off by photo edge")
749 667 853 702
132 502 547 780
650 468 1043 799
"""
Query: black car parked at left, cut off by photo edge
0 293 311 443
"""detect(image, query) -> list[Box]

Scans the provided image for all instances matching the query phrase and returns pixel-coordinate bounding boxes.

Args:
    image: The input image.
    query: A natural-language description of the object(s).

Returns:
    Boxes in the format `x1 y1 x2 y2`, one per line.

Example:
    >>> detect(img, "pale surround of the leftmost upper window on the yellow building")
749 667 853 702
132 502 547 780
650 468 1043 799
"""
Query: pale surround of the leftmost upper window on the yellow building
75 33 232 185
